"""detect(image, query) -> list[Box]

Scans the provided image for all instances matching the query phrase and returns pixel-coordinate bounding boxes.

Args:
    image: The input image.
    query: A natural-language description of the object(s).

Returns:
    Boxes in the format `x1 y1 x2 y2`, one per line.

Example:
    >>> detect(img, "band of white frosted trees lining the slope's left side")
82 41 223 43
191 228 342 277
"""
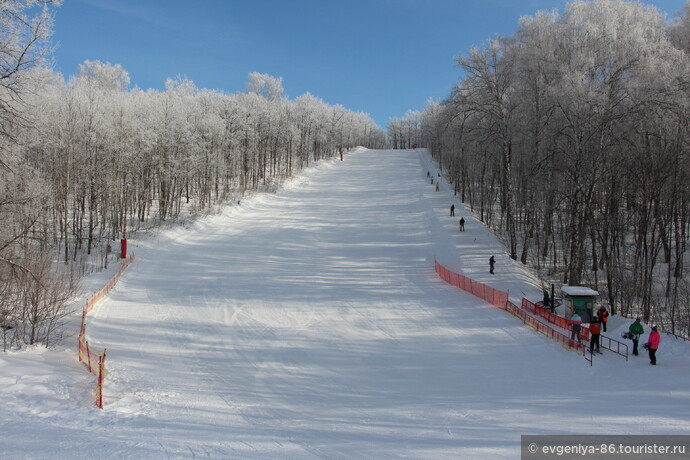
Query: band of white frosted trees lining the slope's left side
0 0 386 347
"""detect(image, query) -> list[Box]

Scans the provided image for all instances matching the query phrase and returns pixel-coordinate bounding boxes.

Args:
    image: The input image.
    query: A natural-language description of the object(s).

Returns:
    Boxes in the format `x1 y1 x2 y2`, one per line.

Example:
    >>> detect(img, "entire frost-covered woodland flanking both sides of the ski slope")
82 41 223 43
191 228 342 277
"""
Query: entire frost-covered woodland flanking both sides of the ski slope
0 0 690 346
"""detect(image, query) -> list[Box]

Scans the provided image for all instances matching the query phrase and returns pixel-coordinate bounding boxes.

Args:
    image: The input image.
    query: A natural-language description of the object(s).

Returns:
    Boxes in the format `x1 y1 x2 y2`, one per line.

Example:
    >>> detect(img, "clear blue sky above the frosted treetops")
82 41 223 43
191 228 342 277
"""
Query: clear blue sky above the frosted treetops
54 0 685 128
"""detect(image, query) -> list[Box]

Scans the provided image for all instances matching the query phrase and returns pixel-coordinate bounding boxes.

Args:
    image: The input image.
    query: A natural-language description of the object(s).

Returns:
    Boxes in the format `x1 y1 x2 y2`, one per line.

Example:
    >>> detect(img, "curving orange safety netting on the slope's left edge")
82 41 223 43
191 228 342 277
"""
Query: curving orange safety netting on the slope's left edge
79 254 134 409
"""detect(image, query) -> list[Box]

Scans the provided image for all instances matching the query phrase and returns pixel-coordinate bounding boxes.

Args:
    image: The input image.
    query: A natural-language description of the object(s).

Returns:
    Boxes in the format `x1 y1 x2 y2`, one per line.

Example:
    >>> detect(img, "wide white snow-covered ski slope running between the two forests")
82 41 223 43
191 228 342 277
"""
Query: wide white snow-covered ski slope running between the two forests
0 150 690 459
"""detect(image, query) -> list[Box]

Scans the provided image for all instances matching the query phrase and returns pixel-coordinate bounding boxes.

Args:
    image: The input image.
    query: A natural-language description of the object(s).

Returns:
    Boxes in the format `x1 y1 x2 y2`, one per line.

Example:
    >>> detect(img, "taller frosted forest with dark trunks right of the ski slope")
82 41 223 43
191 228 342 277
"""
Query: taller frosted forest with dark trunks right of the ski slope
388 0 690 337
